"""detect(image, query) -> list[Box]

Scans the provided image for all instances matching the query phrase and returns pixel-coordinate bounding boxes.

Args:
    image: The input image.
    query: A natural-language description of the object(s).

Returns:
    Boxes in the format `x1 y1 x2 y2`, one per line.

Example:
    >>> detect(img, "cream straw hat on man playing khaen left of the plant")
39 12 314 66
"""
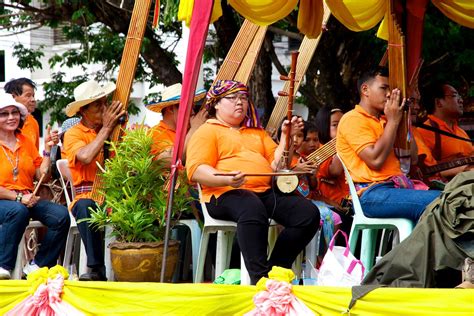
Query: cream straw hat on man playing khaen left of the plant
65 80 115 117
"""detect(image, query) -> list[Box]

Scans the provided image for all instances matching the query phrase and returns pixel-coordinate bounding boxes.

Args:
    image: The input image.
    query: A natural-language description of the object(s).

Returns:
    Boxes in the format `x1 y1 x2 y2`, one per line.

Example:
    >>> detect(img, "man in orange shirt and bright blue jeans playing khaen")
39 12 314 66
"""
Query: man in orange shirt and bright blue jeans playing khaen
336 68 440 222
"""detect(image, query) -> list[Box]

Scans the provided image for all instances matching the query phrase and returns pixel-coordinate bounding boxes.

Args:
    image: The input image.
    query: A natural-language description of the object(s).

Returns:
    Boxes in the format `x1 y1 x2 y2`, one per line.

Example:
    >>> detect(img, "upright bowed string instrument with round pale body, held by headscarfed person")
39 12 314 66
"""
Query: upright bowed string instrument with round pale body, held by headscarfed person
276 51 299 193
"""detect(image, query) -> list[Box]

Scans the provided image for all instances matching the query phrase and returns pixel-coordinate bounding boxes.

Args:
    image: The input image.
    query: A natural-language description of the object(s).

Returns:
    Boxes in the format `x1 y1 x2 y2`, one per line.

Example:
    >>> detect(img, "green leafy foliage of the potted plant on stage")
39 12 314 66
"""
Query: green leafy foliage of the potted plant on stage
86 127 193 242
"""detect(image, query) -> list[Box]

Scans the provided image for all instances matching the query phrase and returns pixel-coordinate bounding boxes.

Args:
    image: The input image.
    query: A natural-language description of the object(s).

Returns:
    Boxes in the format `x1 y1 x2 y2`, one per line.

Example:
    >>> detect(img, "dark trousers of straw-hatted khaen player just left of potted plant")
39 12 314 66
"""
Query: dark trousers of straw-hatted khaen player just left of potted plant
72 199 104 269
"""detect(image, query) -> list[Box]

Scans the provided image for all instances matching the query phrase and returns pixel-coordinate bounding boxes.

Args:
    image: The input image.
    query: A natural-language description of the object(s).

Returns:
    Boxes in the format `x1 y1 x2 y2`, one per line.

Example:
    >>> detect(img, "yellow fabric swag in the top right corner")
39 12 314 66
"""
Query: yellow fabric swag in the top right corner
431 0 474 28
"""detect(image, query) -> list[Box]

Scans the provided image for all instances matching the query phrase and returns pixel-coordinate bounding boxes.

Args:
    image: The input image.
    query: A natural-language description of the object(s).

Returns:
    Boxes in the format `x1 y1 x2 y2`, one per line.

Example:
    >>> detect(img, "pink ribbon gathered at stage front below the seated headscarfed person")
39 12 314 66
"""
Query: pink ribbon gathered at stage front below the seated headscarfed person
245 280 314 316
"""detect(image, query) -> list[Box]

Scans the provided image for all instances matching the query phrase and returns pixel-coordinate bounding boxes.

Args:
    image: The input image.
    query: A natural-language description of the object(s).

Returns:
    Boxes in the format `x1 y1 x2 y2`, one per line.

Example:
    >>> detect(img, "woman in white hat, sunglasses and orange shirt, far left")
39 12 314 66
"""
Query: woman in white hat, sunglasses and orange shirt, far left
0 94 70 279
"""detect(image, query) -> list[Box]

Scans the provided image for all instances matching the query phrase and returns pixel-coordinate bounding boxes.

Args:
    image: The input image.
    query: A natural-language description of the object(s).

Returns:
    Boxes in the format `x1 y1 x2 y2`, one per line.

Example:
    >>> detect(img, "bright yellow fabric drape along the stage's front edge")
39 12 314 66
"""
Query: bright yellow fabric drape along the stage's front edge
0 281 474 316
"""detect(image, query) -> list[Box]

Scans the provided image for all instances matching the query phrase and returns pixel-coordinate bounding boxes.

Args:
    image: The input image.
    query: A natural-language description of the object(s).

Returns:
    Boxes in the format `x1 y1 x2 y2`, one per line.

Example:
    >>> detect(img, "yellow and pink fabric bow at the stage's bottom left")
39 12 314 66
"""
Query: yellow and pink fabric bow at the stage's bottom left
5 265 84 316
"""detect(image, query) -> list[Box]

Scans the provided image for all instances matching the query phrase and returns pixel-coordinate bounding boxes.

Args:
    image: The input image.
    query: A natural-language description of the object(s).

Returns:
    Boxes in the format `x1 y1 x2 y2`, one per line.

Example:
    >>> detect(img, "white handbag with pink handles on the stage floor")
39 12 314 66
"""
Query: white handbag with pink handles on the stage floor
318 230 365 286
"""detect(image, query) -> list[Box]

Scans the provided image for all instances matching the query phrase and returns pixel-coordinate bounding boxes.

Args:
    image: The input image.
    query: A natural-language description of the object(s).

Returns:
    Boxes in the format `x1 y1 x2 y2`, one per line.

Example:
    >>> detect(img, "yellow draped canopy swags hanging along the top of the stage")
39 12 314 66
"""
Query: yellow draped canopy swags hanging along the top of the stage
178 0 474 37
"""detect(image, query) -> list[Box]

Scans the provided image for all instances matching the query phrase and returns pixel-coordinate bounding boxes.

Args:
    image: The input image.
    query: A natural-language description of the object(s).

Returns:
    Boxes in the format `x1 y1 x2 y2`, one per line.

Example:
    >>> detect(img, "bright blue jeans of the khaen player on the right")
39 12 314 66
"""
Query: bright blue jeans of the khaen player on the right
360 182 441 223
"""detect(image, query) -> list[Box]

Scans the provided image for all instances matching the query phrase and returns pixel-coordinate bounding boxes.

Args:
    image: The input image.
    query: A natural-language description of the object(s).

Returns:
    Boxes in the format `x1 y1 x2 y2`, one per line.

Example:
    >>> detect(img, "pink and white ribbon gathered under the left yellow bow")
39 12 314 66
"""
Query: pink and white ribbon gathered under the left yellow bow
5 274 83 316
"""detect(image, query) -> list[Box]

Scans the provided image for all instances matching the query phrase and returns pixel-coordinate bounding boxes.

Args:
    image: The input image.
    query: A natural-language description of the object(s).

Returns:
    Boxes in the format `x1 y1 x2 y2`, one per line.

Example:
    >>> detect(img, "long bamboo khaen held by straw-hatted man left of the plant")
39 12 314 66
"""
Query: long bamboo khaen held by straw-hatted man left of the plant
91 0 152 205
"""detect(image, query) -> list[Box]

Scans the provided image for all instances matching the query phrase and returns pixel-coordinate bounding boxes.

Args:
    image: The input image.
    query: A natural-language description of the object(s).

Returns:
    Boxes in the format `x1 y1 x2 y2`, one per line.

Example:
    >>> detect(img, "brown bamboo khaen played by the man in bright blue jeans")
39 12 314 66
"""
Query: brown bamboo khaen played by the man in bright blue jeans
388 0 411 174
